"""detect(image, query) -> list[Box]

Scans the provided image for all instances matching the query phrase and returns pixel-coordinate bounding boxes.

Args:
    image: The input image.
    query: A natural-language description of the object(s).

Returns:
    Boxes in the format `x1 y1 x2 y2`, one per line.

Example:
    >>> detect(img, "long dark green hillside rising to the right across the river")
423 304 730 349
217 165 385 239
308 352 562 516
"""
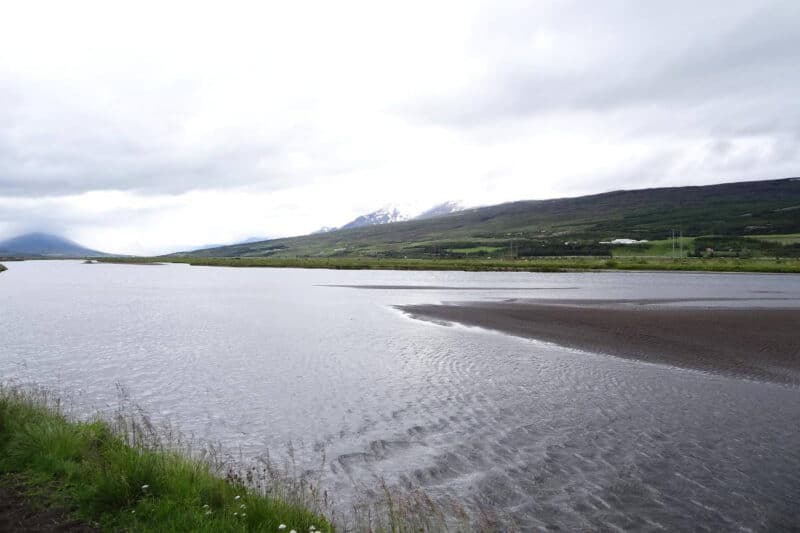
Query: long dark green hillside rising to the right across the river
177 178 800 257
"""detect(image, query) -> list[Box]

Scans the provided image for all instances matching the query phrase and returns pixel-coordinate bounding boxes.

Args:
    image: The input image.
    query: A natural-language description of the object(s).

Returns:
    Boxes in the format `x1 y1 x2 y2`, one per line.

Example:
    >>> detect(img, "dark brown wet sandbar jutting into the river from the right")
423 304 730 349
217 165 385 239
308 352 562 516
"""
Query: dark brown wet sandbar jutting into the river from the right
398 300 800 385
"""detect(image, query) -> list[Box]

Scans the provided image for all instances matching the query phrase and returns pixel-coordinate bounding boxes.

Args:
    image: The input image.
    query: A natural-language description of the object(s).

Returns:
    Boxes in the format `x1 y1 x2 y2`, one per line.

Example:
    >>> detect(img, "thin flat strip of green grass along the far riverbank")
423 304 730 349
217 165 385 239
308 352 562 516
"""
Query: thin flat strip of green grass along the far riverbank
100 256 800 273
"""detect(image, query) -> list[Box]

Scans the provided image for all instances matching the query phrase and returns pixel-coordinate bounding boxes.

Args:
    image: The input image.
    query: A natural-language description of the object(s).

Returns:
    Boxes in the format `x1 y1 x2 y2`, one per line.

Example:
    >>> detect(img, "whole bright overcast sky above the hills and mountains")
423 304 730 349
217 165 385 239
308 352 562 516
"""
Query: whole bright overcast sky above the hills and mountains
0 0 800 254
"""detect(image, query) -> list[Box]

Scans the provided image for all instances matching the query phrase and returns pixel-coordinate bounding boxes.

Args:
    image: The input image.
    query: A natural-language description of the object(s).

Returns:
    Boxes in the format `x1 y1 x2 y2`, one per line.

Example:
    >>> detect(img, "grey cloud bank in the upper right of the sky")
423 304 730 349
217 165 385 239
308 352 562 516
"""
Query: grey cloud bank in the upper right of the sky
412 2 800 137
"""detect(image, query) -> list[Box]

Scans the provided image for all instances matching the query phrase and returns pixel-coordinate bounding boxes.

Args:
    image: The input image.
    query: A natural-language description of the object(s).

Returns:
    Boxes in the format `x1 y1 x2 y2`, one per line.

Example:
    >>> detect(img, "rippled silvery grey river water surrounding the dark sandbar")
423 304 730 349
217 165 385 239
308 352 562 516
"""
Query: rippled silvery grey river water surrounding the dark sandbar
0 261 800 531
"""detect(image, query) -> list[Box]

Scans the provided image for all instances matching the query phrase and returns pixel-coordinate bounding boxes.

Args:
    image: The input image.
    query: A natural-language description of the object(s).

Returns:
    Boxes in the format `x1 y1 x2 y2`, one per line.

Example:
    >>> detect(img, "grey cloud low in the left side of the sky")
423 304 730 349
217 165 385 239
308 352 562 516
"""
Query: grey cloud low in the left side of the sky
0 78 349 196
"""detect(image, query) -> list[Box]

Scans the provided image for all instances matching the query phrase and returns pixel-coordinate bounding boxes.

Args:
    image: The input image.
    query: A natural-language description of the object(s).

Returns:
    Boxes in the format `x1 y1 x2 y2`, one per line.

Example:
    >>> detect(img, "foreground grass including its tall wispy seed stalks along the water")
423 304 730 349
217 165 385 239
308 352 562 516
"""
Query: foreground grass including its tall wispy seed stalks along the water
0 385 472 533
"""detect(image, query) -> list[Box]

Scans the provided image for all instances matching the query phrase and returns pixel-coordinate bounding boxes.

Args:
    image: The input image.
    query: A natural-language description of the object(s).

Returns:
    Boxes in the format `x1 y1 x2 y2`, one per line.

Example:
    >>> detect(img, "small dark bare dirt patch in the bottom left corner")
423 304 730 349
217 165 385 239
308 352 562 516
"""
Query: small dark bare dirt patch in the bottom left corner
0 476 100 533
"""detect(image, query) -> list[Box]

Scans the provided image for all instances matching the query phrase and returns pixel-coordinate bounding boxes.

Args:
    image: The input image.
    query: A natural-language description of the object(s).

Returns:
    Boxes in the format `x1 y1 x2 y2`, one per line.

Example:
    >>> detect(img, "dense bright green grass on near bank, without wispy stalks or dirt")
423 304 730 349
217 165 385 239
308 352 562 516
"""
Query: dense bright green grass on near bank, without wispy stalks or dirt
0 391 332 532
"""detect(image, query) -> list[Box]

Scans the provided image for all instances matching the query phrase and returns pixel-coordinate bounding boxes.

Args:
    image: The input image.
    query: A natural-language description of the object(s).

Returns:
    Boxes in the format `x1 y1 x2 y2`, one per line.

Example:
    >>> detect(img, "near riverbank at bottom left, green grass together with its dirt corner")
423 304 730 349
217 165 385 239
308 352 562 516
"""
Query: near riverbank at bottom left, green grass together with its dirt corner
0 386 335 533
